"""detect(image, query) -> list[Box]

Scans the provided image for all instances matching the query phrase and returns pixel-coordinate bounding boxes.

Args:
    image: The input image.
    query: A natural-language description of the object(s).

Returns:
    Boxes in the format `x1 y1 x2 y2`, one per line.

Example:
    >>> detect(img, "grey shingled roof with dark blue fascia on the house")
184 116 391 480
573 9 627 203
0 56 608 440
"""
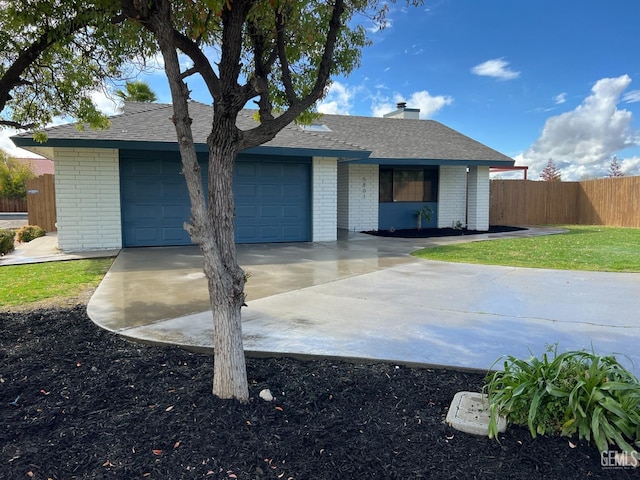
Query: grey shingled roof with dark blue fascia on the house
12 102 514 166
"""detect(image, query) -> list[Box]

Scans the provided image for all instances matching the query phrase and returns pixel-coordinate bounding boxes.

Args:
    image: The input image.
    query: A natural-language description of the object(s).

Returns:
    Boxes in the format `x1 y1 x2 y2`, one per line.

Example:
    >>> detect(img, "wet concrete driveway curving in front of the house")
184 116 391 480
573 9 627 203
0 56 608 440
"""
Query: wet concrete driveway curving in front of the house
88 229 640 375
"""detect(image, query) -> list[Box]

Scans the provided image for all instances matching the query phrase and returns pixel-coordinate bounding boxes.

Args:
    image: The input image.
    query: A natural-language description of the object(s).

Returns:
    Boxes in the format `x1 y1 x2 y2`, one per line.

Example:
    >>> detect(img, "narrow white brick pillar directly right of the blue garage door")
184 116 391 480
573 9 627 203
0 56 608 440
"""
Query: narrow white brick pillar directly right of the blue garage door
311 157 338 242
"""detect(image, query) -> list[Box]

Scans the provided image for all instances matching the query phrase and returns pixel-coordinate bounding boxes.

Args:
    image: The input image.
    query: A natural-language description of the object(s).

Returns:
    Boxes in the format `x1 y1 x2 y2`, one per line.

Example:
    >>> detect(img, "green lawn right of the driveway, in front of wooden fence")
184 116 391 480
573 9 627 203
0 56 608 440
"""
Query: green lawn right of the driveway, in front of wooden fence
413 226 640 272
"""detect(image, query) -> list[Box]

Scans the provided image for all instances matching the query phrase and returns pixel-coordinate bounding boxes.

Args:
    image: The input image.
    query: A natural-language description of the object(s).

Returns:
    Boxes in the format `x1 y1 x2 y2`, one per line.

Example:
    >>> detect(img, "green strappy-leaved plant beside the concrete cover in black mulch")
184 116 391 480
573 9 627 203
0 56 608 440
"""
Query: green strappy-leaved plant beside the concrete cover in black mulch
483 345 640 452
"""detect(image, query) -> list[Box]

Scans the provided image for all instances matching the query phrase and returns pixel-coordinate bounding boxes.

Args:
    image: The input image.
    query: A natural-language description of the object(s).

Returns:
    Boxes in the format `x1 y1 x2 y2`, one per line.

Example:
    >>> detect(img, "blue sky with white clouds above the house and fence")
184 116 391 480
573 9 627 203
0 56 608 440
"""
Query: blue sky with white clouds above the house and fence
5 0 640 180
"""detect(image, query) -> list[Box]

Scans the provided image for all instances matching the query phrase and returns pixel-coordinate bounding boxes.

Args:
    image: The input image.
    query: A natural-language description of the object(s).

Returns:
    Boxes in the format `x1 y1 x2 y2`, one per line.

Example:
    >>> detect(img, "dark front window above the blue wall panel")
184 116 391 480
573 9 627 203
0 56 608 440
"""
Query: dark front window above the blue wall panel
379 167 438 203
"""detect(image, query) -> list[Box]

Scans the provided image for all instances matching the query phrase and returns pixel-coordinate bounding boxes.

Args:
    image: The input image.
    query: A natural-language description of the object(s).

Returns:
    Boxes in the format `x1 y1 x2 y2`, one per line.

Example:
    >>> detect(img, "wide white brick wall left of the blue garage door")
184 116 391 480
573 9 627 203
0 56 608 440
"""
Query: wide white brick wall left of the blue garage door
53 148 122 252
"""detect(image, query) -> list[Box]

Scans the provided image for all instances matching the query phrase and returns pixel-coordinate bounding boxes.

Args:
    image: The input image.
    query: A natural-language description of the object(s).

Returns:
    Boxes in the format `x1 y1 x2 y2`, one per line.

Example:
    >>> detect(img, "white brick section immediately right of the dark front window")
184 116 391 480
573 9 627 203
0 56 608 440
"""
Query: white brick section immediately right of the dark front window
438 165 467 228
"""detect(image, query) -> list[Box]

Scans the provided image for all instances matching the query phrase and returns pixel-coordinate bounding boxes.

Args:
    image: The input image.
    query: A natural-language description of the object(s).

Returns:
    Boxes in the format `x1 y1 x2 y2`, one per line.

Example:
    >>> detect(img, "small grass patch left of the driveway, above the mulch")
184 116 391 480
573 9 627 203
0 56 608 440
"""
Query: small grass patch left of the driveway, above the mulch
0 258 113 308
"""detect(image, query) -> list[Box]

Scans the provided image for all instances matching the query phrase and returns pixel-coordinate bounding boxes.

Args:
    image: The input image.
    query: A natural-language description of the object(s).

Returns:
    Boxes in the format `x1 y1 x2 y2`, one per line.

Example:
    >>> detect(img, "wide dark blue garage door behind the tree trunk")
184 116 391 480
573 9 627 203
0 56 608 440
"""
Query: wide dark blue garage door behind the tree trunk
120 151 311 247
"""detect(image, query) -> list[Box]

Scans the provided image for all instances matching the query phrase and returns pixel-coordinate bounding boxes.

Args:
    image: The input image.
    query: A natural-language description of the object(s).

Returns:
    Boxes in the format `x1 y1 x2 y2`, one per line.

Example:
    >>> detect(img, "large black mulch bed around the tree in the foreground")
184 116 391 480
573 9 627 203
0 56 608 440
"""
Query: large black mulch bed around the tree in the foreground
0 306 638 480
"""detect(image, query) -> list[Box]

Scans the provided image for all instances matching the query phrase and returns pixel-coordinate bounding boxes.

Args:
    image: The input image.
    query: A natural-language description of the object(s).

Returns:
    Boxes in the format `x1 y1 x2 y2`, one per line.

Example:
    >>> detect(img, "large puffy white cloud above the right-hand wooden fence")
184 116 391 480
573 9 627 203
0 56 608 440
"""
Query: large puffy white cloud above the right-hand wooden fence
518 75 640 180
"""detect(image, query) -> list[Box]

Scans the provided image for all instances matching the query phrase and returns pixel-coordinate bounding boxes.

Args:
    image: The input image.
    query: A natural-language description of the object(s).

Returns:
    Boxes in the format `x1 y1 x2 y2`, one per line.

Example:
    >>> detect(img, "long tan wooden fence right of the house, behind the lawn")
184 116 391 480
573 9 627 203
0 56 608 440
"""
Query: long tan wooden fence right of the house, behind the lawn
489 177 640 228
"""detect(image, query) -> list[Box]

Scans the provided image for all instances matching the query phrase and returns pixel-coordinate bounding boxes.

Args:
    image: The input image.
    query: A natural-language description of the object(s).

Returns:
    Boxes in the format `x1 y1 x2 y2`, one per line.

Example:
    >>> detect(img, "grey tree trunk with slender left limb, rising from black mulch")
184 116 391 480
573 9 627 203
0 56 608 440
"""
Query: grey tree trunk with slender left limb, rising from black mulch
150 2 249 402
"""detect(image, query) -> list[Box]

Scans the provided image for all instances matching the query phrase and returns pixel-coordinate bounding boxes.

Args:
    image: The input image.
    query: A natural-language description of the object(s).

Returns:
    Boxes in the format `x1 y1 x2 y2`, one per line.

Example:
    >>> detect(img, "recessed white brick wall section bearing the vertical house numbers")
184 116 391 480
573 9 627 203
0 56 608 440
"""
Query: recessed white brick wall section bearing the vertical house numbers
338 164 379 232
